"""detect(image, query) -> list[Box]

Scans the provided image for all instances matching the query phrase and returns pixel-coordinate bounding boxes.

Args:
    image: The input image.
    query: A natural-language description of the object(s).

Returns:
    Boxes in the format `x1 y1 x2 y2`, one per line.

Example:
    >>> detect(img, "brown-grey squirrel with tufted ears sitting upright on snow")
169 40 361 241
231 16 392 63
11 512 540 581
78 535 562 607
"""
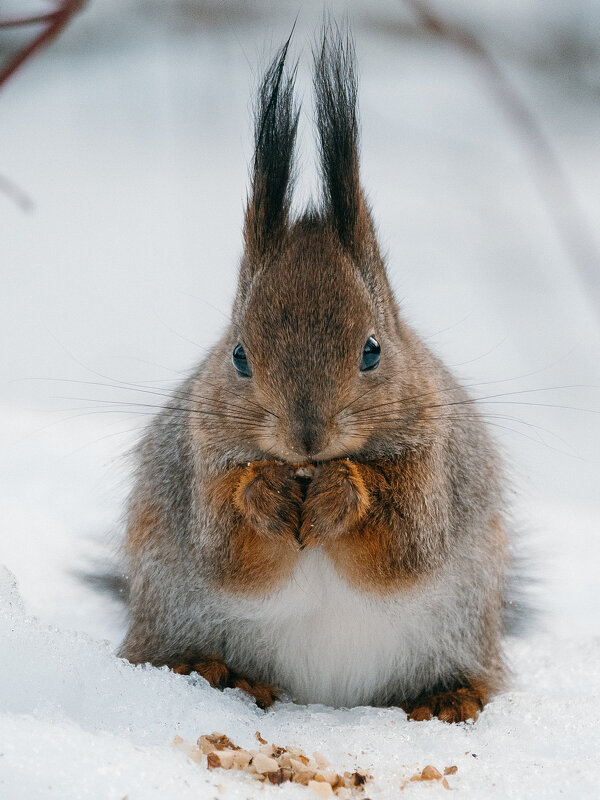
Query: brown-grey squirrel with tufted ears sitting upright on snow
120 25 511 722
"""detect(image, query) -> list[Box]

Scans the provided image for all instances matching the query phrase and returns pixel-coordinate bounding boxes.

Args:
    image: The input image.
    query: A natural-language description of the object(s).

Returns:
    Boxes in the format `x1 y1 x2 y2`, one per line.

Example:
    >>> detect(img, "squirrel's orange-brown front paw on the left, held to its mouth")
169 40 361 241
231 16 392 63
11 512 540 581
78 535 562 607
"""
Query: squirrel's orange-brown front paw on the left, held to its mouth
233 461 302 536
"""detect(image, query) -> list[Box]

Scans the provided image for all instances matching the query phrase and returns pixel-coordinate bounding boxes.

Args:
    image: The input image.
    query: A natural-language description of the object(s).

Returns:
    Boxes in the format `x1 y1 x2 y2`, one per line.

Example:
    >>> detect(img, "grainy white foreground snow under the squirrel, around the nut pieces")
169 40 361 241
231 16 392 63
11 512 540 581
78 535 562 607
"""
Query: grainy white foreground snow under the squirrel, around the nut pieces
0 569 600 800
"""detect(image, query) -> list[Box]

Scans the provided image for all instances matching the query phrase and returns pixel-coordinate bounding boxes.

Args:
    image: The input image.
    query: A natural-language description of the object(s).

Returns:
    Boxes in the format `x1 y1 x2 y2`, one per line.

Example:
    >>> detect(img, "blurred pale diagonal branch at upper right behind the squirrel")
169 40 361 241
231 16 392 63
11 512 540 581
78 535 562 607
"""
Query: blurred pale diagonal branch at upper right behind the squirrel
404 0 600 317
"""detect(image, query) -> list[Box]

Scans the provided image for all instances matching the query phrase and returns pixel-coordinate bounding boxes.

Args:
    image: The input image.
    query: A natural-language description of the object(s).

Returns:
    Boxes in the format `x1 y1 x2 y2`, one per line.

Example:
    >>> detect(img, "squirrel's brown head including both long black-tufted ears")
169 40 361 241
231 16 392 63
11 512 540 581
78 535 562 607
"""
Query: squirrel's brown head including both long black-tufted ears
211 26 436 462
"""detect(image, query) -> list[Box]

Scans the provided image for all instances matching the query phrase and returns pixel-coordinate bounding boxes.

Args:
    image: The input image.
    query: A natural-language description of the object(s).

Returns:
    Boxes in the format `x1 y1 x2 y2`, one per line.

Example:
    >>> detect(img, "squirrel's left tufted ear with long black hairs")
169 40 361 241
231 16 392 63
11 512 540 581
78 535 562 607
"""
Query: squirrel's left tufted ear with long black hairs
244 35 299 269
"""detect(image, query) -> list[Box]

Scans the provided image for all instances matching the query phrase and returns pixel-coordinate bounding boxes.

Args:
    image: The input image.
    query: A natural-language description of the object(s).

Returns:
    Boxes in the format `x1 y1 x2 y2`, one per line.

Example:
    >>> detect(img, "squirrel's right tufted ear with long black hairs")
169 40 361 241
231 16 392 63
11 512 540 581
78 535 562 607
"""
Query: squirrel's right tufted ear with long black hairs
314 22 373 255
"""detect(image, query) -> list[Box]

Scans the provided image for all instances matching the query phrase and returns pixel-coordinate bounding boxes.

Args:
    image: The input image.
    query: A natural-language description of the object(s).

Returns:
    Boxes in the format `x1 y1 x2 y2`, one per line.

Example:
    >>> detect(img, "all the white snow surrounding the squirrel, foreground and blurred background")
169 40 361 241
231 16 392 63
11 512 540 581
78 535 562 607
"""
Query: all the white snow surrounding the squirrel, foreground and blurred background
0 0 600 800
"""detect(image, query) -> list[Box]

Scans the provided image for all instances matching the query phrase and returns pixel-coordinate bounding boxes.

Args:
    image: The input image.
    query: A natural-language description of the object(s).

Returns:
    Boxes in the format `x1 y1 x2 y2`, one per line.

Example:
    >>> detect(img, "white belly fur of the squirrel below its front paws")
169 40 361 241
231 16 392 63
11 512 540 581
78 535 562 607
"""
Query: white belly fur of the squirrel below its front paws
220 549 446 706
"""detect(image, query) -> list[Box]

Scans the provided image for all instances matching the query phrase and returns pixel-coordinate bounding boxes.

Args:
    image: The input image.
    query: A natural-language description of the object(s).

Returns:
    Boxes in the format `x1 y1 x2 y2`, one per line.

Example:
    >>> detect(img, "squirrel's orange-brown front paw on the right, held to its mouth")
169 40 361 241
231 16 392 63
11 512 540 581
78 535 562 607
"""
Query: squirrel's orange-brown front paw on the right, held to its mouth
300 459 370 547
